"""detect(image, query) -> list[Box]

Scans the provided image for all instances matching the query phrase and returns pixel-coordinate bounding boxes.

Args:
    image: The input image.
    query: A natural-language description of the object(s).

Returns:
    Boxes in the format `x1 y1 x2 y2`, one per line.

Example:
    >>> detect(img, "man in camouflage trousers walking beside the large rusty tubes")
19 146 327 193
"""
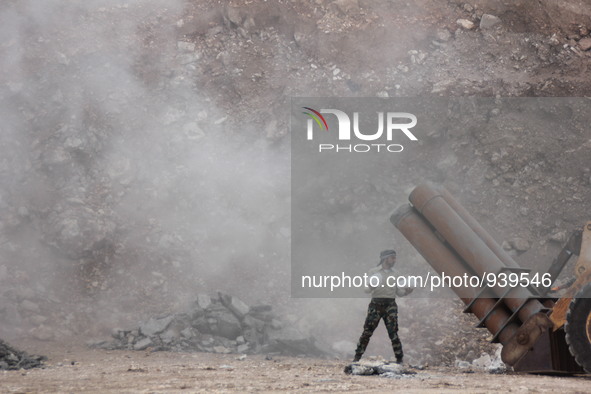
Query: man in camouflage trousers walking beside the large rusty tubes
353 250 413 364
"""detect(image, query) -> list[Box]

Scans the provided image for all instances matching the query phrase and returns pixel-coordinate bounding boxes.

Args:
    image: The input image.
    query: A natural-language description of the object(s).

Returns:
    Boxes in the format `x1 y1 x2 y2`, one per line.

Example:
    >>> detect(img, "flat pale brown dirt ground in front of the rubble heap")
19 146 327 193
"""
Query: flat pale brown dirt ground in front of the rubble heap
0 343 591 393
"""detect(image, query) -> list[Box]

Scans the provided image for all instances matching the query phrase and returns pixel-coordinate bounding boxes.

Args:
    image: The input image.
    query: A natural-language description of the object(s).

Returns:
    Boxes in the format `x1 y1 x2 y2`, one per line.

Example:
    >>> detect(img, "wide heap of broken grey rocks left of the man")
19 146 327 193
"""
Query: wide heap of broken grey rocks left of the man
91 293 330 357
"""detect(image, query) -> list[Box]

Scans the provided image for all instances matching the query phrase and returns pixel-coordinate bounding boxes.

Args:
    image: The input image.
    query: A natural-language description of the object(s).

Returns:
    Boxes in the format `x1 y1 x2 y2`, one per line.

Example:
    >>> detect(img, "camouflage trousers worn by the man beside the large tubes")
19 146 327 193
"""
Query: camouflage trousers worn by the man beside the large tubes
355 298 403 360
